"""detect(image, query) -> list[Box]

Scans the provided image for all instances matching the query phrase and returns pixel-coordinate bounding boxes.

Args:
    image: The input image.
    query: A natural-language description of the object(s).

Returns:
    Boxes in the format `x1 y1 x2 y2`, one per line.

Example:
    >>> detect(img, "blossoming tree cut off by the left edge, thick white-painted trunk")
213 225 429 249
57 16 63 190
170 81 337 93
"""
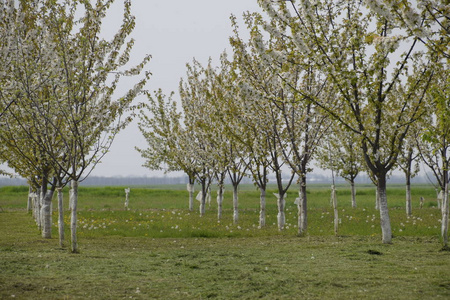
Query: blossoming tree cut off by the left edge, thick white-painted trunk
0 1 68 238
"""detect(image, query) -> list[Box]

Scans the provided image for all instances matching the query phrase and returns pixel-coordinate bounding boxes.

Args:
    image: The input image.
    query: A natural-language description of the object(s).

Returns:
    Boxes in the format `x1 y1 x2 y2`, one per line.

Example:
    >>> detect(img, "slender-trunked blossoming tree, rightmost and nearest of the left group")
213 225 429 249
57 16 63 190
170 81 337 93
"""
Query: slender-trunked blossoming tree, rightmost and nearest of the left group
42 0 150 252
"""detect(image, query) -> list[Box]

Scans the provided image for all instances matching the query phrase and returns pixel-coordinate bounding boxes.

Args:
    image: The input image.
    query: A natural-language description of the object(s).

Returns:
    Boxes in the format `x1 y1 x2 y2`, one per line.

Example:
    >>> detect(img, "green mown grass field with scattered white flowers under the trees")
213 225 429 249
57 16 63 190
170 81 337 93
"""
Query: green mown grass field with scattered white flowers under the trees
0 185 450 299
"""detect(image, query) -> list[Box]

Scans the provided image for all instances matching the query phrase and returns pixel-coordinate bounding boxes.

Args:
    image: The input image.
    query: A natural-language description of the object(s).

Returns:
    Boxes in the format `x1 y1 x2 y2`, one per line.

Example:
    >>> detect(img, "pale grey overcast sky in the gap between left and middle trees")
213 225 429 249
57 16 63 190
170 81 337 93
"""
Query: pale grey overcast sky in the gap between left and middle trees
91 0 260 176
